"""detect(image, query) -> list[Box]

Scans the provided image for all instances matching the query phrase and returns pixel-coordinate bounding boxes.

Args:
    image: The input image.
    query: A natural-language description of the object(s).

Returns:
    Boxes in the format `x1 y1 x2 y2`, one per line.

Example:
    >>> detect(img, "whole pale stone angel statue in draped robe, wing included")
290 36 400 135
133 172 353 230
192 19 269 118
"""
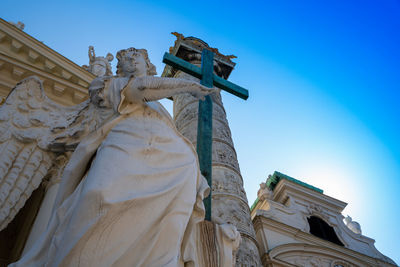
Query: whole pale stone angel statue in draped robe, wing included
9 48 214 267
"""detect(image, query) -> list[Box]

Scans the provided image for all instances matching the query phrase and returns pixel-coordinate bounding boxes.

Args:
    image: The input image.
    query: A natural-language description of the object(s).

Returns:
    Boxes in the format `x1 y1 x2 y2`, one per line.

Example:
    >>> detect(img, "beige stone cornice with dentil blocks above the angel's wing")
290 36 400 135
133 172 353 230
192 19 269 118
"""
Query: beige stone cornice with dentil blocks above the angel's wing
0 19 95 105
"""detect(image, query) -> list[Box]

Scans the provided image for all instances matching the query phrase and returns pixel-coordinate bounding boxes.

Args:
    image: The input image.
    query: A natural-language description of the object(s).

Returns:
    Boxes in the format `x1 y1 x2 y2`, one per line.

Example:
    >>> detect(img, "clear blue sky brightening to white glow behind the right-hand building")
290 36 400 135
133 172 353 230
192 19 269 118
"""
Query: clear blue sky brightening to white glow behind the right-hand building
0 0 400 264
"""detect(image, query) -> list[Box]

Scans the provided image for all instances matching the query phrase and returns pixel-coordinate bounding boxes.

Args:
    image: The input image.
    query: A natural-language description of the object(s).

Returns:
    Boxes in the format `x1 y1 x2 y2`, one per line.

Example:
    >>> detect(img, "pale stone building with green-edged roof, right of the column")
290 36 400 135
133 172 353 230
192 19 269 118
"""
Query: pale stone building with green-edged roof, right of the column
251 172 397 267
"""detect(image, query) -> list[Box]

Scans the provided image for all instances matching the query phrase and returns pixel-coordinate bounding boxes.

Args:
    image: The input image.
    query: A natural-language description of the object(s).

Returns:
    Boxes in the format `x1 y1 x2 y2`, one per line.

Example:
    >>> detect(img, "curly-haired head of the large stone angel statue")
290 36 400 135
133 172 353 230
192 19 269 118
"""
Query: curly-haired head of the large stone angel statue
117 47 157 77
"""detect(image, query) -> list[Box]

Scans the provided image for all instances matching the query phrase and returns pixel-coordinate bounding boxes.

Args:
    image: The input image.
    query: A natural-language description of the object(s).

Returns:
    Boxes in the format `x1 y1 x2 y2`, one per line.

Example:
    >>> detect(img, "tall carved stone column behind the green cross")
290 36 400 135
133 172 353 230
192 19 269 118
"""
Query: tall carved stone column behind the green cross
163 37 261 266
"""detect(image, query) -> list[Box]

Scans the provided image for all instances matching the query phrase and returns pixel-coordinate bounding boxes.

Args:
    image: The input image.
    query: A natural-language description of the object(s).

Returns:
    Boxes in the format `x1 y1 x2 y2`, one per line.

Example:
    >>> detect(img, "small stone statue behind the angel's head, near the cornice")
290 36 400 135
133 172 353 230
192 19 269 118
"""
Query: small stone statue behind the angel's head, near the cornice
82 46 114 77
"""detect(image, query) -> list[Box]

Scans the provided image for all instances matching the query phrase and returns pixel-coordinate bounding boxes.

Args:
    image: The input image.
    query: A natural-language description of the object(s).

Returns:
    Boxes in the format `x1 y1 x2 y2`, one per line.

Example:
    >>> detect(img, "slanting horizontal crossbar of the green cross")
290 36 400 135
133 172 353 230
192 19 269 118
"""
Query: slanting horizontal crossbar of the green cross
163 53 249 100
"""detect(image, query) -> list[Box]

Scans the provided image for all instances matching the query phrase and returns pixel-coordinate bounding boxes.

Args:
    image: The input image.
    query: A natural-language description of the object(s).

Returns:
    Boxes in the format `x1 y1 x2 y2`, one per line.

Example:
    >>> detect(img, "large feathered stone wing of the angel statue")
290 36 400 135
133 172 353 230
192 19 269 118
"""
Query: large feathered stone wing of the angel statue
0 76 111 231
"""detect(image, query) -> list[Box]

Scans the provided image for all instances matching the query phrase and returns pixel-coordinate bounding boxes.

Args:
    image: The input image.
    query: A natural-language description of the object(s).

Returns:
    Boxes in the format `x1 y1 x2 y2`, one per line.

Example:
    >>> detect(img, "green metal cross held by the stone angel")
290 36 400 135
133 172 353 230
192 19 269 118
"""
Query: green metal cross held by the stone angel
163 49 249 221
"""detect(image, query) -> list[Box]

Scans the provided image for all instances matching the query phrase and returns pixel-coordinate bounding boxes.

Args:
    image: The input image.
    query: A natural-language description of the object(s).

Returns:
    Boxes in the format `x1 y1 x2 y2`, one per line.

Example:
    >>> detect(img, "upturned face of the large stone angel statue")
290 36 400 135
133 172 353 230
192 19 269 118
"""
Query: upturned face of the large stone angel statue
119 51 147 77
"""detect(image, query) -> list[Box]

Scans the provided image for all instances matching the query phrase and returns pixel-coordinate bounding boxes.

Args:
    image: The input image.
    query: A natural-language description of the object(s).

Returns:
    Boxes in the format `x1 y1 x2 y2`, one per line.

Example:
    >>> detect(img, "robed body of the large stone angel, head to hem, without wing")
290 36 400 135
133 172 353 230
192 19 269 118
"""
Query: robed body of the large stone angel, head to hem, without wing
7 48 215 266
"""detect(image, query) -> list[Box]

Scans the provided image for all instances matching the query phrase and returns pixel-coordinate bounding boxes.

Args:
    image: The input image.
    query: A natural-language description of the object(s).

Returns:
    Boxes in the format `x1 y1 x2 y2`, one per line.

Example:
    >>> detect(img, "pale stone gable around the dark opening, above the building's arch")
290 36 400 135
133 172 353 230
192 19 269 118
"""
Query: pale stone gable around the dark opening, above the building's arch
252 180 394 266
